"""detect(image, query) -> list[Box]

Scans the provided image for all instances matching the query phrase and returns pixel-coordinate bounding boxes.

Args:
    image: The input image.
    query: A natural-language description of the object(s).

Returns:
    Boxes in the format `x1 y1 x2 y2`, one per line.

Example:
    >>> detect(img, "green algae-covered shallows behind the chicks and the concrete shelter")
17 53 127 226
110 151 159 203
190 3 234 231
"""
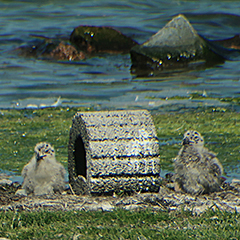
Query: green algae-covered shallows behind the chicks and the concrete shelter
0 108 240 174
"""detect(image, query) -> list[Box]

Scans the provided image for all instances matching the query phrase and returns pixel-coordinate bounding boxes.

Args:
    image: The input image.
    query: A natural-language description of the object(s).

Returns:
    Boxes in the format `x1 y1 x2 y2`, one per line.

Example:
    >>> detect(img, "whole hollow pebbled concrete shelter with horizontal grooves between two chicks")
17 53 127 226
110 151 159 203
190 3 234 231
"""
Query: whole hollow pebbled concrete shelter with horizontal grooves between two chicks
68 110 160 194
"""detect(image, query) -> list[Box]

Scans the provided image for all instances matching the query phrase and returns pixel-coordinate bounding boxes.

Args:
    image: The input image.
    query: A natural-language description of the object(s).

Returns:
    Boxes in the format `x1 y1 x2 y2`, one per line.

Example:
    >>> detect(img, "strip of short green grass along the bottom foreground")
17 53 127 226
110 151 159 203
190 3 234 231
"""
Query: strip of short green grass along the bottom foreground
0 209 240 240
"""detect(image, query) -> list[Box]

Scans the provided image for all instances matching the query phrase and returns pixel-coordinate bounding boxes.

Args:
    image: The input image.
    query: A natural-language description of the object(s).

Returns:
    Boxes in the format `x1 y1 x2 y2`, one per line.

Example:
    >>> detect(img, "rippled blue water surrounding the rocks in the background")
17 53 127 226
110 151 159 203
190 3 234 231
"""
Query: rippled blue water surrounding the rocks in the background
0 0 240 109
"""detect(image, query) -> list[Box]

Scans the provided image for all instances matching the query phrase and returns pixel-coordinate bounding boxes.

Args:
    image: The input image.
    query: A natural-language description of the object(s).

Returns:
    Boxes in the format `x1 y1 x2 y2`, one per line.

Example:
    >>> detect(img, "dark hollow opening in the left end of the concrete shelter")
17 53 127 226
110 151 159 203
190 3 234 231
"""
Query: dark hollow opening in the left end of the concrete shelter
74 136 87 179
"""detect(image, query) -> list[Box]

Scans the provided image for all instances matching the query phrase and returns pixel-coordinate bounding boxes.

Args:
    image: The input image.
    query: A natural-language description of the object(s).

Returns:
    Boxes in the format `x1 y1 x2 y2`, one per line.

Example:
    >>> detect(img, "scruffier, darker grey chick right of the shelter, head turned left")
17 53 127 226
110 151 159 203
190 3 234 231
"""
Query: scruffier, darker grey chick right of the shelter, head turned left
174 130 223 195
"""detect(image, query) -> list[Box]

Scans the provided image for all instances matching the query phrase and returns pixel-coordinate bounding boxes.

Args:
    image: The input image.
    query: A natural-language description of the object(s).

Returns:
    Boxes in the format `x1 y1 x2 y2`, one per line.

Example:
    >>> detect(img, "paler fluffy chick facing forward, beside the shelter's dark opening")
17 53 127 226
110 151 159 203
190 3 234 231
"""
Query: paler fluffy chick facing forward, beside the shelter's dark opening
22 142 65 195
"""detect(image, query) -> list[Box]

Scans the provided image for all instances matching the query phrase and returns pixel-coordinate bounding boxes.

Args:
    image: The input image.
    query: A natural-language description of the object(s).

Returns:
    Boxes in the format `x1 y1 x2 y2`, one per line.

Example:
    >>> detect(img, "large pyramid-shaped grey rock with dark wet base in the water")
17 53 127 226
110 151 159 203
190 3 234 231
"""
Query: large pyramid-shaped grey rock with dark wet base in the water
130 15 222 76
